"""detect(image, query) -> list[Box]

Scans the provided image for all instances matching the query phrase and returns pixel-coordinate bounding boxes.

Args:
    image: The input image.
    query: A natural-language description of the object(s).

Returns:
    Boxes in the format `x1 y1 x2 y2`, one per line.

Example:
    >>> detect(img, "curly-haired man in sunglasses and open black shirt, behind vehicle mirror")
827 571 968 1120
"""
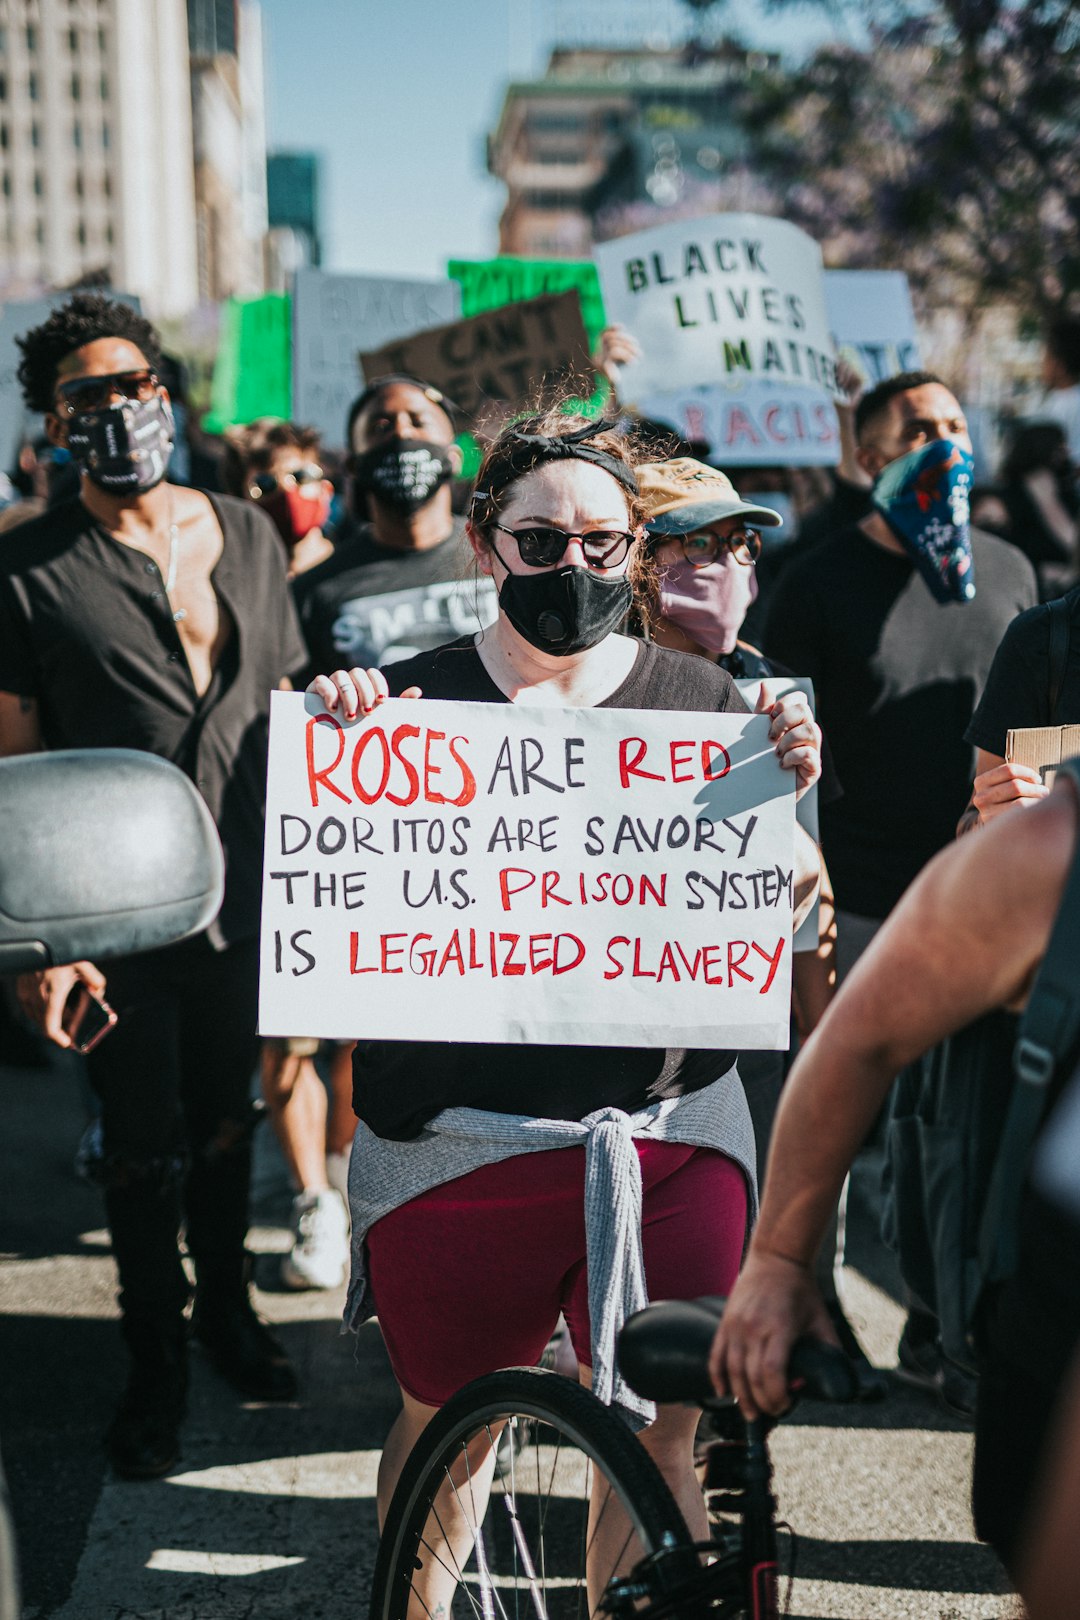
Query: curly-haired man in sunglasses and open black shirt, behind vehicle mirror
0 293 304 1479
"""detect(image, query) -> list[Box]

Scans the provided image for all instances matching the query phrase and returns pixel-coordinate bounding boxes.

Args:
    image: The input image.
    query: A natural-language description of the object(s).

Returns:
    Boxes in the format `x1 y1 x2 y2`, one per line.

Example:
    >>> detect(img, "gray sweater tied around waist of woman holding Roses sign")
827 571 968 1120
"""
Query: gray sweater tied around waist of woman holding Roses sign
345 1066 758 1429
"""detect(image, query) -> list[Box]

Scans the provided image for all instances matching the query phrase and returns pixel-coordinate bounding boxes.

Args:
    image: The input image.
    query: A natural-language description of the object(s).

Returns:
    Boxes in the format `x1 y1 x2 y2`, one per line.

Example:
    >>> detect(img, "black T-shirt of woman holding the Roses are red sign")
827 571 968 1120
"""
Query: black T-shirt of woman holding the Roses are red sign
353 635 748 1140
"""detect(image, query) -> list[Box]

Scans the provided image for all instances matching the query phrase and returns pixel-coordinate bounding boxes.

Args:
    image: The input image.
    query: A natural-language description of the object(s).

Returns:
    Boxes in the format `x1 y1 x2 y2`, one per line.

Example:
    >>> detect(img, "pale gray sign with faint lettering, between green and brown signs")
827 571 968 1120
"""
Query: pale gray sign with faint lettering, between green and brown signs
293 269 461 449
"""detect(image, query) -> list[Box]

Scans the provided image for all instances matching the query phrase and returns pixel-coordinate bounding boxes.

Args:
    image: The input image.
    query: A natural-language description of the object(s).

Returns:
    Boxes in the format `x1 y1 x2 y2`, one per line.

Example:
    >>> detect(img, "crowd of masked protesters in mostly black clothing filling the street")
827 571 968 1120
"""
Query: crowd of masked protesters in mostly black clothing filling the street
0 295 1080 1614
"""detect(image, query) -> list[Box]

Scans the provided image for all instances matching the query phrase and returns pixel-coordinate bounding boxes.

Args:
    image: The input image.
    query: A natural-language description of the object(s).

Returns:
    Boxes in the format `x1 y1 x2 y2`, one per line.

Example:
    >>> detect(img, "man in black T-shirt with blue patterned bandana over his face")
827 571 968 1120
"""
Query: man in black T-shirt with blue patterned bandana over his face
764 371 1036 1406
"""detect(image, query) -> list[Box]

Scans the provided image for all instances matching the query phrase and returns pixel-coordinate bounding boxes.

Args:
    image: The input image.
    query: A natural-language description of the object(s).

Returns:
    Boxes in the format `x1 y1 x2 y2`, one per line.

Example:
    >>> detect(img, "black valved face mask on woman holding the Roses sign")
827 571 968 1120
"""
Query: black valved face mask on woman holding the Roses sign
499 564 633 658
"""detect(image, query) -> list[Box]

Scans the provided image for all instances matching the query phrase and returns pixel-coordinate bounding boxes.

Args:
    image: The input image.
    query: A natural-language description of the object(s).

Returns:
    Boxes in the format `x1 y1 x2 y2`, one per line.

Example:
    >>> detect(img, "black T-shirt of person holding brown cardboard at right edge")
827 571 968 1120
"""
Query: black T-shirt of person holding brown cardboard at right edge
965 586 1080 760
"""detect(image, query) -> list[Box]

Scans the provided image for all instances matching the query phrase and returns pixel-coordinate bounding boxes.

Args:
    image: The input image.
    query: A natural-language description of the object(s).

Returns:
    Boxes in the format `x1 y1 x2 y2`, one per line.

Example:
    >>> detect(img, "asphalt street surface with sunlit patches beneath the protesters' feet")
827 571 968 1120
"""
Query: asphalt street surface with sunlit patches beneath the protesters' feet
0 1063 1020 1620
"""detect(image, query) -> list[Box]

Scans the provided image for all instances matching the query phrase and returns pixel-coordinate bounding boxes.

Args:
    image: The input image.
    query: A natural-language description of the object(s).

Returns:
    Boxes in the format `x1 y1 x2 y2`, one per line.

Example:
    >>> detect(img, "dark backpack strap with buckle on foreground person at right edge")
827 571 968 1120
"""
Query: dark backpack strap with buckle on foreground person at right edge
978 758 1080 1283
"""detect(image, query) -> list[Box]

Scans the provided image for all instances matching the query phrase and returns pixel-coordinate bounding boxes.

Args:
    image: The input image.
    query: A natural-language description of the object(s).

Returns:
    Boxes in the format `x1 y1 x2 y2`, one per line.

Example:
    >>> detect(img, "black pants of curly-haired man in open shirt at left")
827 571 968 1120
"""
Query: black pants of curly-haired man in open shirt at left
87 935 259 1348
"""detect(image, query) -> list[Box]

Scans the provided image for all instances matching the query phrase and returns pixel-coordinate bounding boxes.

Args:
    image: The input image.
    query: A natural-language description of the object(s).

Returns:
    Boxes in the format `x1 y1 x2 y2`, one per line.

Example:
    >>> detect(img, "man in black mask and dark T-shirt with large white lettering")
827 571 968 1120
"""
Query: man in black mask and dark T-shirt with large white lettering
295 377 495 671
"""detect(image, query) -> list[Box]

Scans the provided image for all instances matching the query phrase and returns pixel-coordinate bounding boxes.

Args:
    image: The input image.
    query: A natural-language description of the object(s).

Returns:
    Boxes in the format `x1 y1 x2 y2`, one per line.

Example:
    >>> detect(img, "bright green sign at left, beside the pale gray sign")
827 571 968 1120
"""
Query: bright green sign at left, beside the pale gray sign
202 293 291 433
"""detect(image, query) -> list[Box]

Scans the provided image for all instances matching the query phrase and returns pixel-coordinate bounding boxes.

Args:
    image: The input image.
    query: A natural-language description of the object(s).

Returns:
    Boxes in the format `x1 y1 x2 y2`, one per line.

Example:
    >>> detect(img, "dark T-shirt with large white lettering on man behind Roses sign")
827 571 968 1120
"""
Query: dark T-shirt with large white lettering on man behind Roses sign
293 518 497 676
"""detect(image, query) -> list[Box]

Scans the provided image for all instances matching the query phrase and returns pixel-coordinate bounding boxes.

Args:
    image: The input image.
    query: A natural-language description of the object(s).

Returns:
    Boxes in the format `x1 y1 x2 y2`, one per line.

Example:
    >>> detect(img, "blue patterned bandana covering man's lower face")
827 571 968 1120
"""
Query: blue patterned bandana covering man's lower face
873 439 975 603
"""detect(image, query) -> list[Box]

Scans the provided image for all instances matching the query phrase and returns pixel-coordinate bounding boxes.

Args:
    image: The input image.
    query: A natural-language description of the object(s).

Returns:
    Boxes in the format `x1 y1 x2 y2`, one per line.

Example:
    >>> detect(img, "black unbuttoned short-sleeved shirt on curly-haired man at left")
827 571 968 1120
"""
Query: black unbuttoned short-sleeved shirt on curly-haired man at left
0 496 304 948
